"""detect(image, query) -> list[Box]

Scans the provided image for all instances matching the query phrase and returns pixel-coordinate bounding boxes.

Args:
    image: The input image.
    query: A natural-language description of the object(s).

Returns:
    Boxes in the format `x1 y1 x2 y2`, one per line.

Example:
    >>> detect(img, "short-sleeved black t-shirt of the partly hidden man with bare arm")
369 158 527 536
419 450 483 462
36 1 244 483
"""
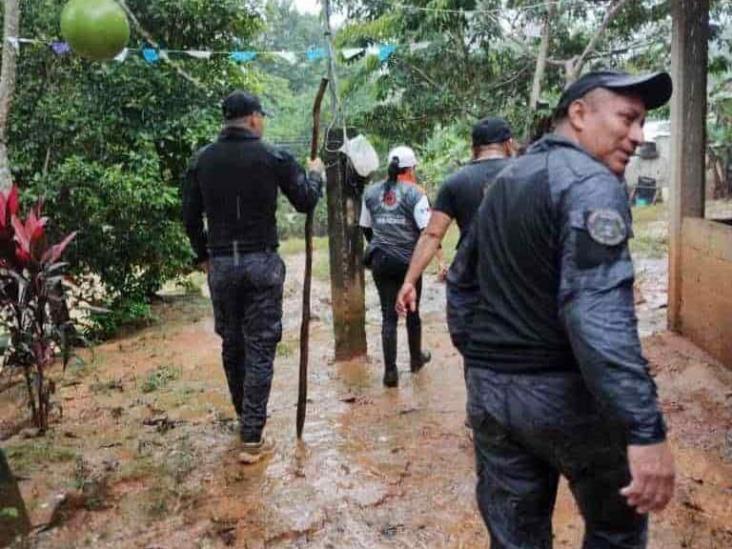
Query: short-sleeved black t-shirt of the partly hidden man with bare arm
432 158 510 247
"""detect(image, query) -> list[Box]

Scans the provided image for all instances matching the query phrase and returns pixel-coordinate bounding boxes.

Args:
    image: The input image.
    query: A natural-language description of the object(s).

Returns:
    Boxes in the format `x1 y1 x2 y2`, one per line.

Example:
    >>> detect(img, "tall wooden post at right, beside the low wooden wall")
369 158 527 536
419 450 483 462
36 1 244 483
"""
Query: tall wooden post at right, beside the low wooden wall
668 0 709 331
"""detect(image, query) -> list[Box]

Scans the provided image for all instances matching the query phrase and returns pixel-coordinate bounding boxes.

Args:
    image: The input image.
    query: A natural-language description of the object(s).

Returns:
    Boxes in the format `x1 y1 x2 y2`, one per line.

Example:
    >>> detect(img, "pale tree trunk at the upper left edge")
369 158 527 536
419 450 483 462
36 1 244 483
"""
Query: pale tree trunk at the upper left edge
0 0 20 190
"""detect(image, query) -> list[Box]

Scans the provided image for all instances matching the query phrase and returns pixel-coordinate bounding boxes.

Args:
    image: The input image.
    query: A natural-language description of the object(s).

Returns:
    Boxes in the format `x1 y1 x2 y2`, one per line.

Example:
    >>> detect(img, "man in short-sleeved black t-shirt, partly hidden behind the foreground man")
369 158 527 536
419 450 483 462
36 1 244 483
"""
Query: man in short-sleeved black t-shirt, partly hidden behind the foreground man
396 117 513 353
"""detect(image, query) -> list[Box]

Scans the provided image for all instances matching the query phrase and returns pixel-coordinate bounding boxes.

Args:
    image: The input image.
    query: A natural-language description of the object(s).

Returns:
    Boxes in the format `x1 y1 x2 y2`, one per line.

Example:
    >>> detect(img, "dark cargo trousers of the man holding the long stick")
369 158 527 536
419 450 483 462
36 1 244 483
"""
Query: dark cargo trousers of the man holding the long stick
208 251 285 442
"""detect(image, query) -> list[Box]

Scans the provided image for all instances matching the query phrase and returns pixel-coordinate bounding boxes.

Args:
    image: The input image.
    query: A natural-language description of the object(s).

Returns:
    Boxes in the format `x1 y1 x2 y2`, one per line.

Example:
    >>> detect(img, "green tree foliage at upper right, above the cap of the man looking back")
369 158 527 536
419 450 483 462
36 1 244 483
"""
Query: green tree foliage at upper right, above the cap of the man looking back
337 0 731 193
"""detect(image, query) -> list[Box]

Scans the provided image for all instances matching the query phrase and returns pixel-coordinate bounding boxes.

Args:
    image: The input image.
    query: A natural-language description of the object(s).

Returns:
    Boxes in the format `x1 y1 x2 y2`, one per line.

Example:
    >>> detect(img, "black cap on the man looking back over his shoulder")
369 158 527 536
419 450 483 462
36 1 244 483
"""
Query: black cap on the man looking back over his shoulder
554 70 673 118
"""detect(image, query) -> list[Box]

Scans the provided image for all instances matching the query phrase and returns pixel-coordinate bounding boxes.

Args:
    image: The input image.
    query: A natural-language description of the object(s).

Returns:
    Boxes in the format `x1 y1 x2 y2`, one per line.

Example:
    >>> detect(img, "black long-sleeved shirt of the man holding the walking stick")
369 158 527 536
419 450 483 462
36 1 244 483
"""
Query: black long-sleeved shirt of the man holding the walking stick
183 127 322 262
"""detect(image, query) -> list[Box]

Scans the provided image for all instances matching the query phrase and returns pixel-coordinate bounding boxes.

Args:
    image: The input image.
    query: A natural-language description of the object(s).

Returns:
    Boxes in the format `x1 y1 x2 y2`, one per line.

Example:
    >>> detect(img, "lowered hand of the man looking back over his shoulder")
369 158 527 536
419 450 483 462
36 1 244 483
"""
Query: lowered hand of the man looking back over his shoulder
620 442 675 514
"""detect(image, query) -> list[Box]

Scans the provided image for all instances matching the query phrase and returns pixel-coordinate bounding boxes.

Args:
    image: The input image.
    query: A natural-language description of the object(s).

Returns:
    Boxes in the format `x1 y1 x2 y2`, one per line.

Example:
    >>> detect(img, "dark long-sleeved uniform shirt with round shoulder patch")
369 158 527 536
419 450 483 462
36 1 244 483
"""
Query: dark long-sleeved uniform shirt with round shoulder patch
465 134 665 443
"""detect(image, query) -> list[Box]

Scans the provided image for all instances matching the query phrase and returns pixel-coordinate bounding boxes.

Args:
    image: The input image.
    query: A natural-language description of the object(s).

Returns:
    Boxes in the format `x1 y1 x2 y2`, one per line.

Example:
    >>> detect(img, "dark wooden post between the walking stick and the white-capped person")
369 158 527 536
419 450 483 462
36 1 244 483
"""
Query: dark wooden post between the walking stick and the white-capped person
325 129 367 360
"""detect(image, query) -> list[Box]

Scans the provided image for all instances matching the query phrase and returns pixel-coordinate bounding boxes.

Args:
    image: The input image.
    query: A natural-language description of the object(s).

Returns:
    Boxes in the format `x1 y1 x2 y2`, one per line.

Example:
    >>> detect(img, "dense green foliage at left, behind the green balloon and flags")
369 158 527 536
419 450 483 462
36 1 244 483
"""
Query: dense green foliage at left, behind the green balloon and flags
10 0 262 334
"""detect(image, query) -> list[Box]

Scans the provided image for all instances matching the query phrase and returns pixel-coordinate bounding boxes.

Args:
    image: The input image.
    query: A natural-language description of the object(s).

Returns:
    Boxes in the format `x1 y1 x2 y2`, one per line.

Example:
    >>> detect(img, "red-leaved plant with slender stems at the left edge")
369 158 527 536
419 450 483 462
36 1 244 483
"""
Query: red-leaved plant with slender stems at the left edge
0 185 76 432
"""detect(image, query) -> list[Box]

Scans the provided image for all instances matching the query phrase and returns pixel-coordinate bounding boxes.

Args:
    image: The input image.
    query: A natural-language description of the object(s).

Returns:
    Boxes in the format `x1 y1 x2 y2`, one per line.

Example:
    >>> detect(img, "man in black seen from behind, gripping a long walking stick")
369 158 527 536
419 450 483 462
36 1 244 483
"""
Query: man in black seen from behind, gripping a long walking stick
183 91 324 463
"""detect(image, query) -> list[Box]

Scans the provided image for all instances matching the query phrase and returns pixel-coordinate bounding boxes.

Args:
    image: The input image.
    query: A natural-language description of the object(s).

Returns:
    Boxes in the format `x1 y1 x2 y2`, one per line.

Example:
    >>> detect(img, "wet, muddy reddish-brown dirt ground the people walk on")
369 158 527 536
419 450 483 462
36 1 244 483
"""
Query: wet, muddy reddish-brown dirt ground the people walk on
0 257 732 549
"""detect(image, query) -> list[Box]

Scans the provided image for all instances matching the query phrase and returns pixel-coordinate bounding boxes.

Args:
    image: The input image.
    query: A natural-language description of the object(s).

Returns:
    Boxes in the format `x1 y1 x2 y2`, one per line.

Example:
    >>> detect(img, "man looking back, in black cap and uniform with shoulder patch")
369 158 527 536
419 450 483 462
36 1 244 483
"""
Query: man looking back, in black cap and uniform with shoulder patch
465 71 674 549
